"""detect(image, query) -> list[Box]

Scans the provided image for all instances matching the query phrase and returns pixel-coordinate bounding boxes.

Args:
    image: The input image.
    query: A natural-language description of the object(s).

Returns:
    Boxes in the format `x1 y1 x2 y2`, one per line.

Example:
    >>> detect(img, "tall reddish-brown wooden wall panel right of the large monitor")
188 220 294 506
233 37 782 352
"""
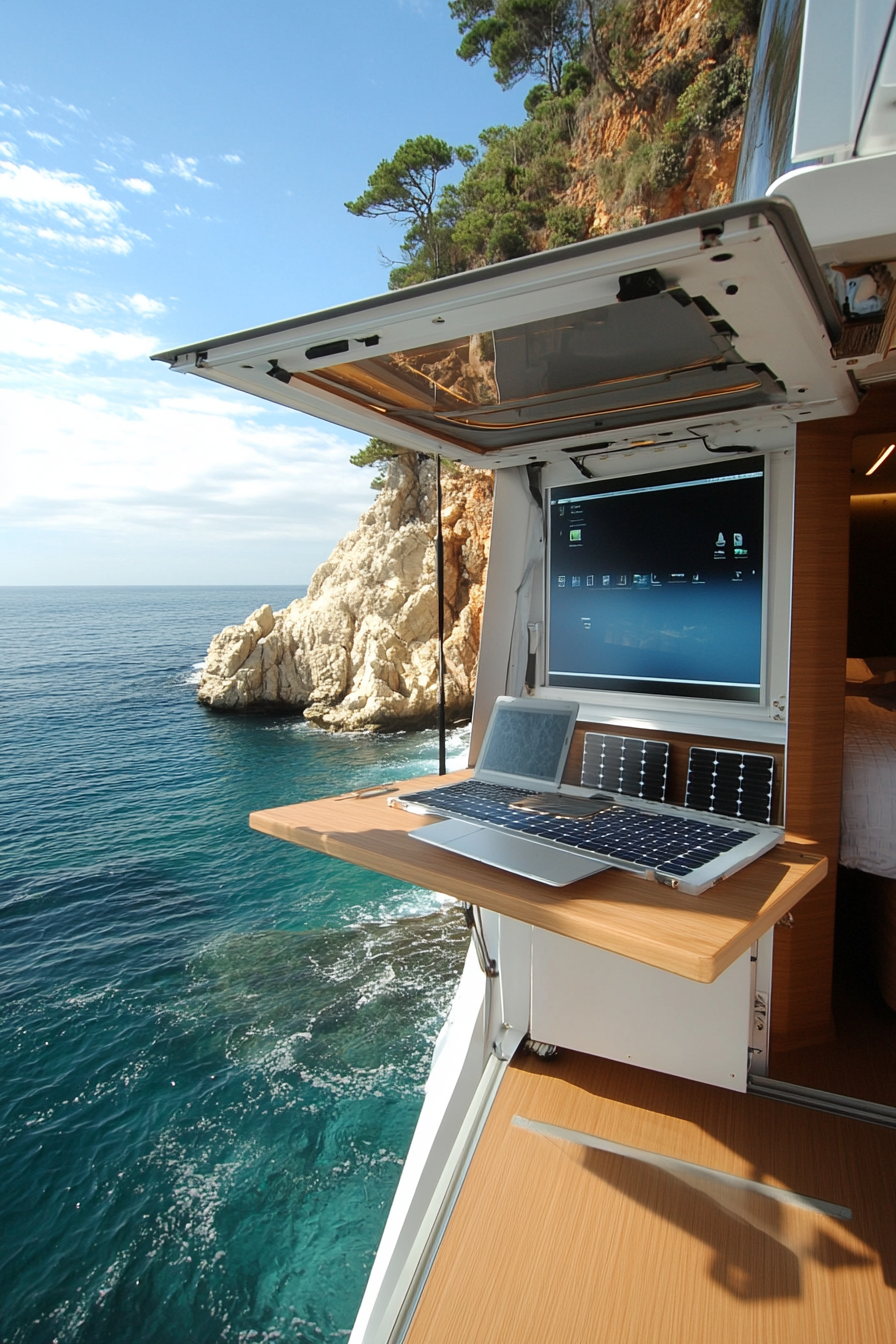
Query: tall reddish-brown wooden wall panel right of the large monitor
770 387 896 1074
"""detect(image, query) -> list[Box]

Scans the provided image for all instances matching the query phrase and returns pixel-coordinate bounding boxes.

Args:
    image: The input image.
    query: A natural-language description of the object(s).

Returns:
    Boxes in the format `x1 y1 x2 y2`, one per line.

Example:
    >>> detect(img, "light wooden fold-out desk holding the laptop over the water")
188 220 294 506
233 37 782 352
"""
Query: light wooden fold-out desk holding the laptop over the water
249 770 827 984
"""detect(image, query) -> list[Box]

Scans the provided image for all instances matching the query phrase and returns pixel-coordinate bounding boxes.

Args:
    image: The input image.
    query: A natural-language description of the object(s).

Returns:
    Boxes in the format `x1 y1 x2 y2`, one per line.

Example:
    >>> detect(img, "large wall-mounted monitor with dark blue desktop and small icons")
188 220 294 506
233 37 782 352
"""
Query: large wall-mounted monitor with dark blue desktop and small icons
547 458 766 704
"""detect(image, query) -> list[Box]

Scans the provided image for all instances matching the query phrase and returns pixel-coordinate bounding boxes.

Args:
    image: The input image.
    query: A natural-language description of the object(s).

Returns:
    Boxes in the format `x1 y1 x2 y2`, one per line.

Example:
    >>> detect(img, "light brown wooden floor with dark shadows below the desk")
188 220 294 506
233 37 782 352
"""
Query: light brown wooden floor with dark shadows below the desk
406 1052 896 1344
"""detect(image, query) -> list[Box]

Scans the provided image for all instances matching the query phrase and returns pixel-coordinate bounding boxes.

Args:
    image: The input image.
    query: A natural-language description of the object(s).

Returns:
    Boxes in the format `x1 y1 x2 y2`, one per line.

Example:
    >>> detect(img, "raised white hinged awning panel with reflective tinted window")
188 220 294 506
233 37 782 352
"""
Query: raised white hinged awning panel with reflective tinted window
154 200 856 465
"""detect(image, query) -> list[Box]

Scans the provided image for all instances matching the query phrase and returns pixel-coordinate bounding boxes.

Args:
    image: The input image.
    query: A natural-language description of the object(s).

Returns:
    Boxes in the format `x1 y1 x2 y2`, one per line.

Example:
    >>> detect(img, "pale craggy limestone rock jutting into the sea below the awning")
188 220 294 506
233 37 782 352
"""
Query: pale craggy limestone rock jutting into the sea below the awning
199 453 492 730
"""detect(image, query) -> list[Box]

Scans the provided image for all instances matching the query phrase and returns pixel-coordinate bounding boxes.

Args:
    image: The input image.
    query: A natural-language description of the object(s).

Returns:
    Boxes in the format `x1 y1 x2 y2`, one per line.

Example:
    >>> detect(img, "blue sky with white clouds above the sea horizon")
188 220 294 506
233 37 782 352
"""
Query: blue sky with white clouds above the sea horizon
0 0 525 583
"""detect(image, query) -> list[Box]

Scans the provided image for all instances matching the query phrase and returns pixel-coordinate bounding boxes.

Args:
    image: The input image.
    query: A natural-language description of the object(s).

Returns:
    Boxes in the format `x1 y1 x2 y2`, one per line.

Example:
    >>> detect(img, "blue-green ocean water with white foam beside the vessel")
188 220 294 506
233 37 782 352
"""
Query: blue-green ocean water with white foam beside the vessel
0 587 466 1344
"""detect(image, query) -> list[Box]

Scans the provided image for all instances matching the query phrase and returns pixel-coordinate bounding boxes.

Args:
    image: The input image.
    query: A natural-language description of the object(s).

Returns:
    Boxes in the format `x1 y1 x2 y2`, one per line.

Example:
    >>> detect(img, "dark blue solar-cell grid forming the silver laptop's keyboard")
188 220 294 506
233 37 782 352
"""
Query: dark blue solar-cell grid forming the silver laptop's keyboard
402 780 756 878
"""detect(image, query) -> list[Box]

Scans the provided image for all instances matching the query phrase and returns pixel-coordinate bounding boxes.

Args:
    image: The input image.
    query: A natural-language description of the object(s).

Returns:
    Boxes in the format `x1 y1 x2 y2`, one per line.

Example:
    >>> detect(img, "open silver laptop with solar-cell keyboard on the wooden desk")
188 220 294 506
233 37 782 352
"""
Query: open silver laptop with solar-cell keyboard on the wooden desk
392 696 783 895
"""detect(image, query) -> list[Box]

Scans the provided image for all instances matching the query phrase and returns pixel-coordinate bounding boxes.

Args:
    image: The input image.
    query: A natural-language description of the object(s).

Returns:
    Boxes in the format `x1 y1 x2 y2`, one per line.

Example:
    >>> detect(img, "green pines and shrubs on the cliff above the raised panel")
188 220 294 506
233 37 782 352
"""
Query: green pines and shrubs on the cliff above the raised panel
347 0 760 289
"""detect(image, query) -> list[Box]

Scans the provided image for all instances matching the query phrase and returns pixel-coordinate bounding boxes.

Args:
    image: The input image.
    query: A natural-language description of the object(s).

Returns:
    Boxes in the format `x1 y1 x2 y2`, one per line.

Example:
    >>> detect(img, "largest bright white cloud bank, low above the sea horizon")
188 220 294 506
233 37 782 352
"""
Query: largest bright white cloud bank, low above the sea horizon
0 371 371 569
